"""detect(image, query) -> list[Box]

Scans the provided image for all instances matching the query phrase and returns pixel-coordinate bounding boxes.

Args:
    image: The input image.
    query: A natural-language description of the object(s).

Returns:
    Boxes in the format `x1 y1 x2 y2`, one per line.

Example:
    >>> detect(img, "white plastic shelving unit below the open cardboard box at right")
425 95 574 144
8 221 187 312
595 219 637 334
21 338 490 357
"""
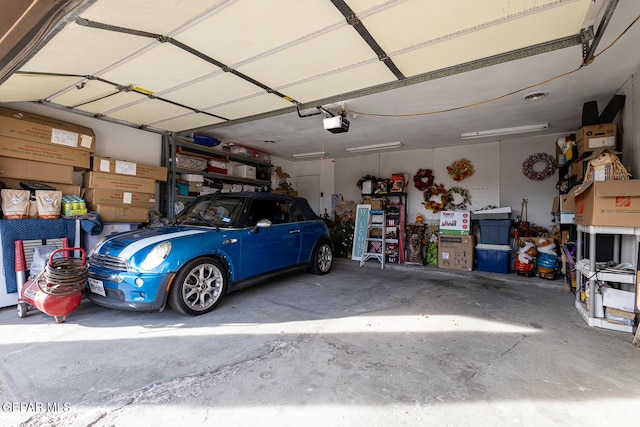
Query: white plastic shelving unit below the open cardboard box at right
575 225 640 332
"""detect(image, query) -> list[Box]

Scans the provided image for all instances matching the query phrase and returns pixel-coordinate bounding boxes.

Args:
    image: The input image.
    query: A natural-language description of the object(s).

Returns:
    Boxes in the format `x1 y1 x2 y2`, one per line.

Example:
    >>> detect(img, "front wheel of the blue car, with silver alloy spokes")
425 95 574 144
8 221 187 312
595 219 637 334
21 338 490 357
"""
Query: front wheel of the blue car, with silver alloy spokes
168 257 228 316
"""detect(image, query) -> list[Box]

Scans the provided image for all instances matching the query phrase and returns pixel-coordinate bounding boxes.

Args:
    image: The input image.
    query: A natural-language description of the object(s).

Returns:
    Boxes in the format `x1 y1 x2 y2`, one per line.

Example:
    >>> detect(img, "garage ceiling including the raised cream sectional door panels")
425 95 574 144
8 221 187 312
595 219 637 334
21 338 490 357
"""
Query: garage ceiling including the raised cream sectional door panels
0 0 640 159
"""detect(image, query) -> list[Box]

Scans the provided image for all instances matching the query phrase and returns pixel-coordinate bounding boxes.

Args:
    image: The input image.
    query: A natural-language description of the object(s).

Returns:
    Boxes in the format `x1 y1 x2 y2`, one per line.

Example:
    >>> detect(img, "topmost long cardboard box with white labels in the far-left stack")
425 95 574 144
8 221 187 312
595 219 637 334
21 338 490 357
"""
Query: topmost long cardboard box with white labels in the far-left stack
0 107 96 153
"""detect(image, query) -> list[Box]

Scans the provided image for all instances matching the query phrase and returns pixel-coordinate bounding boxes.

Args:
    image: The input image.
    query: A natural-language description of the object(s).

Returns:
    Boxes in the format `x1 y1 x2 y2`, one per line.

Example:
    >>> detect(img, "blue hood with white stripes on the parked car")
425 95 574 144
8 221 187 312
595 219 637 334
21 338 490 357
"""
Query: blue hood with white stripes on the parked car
94 225 209 258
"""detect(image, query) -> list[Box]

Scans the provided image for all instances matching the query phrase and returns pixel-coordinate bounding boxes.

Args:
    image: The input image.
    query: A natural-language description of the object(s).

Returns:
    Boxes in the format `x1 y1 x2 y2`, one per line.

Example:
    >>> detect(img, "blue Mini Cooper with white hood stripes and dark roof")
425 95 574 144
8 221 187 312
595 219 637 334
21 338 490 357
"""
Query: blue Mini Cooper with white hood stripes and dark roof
86 192 333 316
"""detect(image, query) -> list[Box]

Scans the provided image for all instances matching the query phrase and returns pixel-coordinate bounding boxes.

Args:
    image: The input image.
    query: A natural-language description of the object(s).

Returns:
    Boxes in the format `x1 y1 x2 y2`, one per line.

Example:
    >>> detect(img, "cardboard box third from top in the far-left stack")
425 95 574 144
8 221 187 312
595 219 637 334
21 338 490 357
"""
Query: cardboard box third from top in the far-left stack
0 157 73 184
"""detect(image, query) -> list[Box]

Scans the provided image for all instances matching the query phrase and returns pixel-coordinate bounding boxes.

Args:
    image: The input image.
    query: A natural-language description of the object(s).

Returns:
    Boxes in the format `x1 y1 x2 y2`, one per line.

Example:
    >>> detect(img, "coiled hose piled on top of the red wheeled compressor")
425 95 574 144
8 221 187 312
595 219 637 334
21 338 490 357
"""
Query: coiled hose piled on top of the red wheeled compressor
36 258 89 296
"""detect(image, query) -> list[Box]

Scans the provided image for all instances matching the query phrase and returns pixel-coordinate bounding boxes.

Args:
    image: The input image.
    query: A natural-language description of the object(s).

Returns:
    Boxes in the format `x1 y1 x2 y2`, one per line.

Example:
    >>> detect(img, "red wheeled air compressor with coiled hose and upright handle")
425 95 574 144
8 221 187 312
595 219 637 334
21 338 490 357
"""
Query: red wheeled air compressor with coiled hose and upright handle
15 241 88 323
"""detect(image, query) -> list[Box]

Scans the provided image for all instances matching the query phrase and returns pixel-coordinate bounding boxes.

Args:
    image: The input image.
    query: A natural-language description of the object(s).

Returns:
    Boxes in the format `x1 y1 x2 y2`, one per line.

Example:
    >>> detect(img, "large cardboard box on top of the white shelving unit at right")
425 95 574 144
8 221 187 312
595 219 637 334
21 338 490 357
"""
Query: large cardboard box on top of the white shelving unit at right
569 179 640 227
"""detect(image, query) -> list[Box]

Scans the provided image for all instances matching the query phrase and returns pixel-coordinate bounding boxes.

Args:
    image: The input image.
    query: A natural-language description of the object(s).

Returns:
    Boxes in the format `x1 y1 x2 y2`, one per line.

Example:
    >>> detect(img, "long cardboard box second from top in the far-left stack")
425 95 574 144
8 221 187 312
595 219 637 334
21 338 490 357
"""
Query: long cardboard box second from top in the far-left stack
0 135 90 169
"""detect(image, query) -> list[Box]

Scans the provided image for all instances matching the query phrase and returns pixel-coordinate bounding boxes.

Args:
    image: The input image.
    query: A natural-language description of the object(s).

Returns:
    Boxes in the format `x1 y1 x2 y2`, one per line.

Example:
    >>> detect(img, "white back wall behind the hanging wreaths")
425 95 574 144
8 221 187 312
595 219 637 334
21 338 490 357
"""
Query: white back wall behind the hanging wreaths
335 140 564 232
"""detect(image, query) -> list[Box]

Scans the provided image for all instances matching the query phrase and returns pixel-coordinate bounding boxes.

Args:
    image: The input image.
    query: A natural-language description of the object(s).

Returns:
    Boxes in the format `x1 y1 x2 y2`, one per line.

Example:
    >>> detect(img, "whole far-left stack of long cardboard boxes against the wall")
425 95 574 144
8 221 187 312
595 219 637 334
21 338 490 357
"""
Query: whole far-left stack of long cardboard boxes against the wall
0 107 96 216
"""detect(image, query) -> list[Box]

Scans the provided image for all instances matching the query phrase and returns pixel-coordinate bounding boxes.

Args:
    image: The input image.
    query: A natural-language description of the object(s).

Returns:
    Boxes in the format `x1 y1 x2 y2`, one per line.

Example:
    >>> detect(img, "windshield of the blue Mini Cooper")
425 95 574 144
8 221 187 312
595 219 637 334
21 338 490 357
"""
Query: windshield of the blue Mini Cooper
175 198 244 227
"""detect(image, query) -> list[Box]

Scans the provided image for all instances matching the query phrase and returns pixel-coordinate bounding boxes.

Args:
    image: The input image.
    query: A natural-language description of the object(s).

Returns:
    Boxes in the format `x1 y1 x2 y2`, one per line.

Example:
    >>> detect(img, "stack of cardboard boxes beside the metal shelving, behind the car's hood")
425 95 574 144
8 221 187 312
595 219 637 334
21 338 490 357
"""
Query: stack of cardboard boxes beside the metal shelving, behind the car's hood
83 156 167 223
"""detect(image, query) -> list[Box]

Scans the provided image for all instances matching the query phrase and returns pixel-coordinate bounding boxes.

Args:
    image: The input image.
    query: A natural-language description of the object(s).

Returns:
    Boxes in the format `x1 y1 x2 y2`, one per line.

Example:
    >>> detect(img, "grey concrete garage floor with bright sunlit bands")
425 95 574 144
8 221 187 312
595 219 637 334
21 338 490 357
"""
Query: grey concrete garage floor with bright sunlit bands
0 259 640 426
